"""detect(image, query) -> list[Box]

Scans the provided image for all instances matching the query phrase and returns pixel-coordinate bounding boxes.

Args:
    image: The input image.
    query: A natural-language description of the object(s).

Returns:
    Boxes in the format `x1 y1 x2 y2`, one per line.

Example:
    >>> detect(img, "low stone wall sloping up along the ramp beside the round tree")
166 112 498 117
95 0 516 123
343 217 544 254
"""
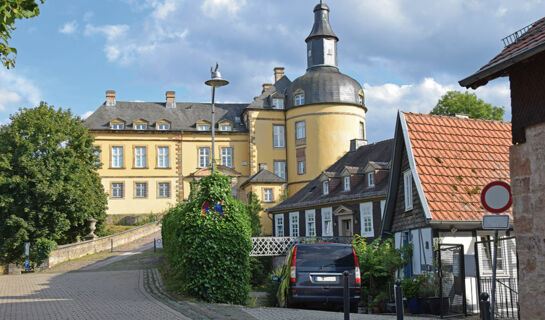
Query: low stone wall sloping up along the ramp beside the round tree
42 221 161 268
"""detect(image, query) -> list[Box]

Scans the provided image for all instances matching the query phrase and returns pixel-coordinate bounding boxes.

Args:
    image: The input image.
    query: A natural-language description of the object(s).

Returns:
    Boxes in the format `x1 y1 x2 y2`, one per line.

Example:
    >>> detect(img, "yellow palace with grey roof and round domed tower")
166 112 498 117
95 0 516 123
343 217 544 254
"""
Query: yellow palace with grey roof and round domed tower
86 3 367 235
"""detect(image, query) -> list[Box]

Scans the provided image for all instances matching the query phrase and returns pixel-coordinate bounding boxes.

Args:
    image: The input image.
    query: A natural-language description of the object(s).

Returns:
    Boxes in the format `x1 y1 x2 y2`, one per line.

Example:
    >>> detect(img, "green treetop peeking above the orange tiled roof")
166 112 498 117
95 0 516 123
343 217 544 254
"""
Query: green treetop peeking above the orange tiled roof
430 91 505 120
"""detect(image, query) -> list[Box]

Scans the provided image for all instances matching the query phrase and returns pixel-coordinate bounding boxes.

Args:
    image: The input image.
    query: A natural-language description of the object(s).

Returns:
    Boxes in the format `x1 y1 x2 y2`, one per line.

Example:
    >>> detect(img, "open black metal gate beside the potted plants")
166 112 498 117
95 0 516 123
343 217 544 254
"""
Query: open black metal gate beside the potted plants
436 243 467 318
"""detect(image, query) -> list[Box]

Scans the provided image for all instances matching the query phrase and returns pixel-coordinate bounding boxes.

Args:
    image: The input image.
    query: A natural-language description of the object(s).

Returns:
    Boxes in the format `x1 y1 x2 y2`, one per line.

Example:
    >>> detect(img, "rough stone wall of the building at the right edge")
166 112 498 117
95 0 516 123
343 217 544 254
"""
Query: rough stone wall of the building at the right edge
510 123 545 319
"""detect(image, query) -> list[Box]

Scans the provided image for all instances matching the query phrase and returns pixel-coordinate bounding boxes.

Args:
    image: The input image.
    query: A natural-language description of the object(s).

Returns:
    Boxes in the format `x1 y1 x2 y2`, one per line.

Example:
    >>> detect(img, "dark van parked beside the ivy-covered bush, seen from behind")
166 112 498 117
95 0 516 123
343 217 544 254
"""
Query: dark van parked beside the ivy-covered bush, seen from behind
274 243 361 312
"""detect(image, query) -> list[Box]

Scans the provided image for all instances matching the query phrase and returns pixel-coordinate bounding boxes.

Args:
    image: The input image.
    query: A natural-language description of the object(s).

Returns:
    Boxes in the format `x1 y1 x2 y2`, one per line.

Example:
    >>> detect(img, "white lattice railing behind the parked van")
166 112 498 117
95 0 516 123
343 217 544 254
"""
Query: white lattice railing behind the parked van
250 237 352 257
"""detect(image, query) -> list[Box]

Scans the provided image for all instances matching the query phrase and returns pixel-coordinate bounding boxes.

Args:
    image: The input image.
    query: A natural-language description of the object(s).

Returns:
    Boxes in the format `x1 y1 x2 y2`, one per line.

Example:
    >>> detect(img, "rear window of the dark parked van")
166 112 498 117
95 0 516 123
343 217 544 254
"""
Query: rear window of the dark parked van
296 246 354 267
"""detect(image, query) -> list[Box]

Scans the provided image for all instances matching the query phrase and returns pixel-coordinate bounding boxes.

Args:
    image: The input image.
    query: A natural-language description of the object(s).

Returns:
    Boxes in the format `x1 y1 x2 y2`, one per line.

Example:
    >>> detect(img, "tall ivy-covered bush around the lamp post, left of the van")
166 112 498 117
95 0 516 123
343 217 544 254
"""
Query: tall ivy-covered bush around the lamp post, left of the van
162 172 252 304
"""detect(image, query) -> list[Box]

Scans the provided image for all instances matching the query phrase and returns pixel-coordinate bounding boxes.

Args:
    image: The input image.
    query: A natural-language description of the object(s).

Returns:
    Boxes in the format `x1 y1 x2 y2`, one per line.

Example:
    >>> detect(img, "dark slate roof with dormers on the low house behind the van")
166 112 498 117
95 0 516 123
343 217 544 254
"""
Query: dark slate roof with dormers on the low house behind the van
267 139 394 212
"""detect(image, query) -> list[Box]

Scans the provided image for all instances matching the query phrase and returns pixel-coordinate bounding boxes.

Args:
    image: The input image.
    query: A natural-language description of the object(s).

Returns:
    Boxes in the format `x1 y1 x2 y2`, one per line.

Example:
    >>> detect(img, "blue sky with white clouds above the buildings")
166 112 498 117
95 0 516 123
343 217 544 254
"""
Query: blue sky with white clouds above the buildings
0 0 545 142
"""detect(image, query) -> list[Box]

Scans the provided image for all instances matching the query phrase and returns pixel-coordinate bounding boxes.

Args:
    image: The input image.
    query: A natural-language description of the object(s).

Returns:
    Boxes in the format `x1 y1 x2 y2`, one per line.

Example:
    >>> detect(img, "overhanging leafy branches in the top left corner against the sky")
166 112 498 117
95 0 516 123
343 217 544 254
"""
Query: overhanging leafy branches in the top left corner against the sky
0 0 44 69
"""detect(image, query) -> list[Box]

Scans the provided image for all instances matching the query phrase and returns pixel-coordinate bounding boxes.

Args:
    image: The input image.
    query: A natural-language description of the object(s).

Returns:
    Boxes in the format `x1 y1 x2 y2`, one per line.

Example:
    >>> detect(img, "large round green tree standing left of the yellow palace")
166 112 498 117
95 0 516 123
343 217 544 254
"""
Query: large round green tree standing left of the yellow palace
0 102 107 262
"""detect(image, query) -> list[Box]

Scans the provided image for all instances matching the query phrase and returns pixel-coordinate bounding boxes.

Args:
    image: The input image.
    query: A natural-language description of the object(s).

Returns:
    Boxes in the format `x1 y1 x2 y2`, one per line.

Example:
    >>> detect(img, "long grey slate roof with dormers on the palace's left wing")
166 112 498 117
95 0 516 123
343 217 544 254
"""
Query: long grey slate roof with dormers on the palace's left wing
85 101 248 132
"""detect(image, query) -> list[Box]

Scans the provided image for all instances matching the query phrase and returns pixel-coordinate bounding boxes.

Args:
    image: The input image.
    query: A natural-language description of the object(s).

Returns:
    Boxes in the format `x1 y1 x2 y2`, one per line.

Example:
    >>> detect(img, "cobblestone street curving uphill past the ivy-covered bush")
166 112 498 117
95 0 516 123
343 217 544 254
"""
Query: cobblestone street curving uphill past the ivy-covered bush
0 234 424 320
